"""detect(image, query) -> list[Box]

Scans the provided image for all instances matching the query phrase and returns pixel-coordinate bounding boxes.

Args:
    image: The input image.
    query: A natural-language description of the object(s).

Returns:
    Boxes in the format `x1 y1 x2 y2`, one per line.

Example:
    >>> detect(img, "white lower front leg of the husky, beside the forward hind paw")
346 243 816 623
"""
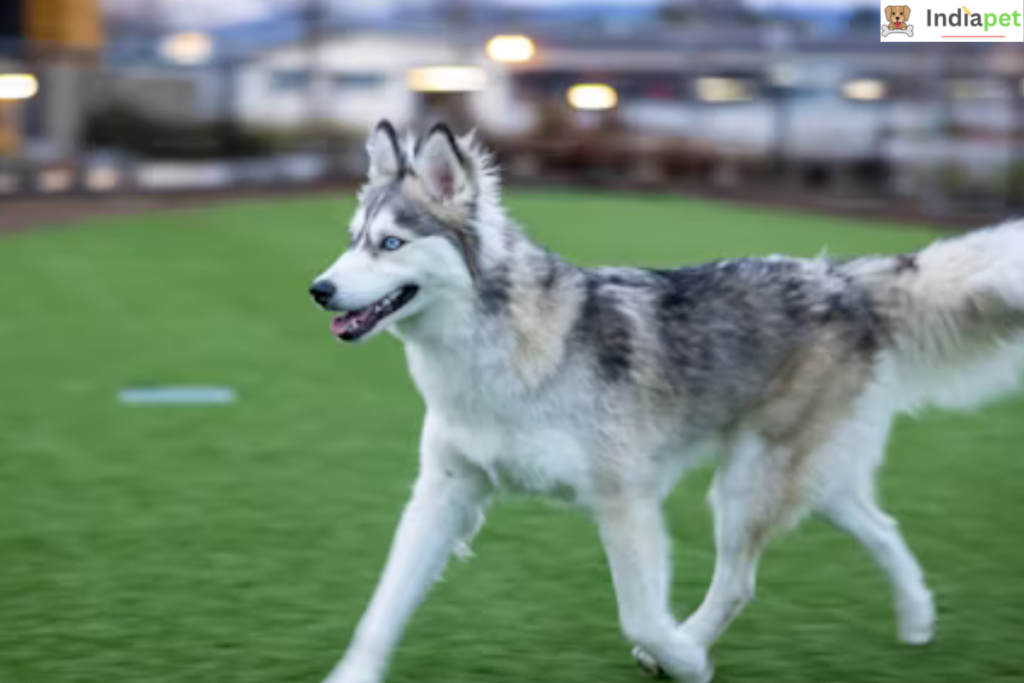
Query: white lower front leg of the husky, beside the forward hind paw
597 494 713 683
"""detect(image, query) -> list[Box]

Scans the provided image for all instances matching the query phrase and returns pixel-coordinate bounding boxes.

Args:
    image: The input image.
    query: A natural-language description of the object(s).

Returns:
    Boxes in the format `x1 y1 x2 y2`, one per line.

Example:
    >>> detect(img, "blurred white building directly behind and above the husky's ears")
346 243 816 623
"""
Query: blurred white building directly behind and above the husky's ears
234 29 530 133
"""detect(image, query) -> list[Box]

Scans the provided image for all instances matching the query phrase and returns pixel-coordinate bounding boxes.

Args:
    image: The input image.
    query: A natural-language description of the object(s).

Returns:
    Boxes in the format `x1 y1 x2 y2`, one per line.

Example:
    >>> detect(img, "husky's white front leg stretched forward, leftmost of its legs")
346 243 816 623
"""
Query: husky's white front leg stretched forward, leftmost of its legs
327 418 489 683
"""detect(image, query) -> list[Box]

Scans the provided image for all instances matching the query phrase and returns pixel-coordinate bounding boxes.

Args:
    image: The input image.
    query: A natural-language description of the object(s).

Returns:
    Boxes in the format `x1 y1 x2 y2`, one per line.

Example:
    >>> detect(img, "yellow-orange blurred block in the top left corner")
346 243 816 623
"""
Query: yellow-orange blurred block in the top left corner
24 0 103 52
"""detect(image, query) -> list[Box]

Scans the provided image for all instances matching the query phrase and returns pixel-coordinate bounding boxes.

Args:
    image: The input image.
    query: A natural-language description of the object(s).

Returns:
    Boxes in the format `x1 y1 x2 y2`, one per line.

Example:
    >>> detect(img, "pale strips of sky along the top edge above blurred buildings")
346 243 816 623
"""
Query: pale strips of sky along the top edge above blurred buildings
100 0 874 26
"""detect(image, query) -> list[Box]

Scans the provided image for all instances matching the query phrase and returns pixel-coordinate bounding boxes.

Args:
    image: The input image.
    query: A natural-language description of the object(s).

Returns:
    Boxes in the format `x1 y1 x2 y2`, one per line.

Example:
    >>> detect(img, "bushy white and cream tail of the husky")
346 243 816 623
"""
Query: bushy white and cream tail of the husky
849 221 1024 410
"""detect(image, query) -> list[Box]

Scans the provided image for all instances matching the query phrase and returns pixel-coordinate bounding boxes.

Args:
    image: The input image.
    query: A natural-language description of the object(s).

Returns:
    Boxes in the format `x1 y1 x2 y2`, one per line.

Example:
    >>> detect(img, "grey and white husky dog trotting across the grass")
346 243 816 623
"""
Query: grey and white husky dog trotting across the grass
310 122 1024 683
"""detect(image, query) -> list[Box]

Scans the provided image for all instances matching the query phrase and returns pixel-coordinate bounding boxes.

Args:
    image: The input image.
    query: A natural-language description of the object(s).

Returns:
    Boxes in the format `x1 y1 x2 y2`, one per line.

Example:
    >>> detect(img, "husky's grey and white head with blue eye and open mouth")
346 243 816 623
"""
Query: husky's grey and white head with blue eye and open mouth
309 121 498 341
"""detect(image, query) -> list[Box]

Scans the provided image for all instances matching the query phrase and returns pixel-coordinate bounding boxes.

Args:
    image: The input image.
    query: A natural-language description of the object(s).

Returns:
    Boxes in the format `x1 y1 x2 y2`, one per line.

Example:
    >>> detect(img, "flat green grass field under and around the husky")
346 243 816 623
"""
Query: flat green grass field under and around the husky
0 194 1024 683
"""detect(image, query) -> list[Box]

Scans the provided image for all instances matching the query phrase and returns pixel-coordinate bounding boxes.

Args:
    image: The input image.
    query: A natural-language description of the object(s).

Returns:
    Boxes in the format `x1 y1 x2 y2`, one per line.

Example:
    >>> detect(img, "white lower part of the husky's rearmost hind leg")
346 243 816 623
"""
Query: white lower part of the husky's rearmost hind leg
822 493 935 645
